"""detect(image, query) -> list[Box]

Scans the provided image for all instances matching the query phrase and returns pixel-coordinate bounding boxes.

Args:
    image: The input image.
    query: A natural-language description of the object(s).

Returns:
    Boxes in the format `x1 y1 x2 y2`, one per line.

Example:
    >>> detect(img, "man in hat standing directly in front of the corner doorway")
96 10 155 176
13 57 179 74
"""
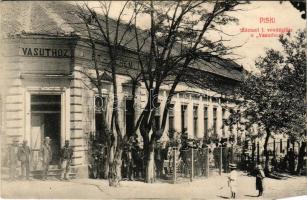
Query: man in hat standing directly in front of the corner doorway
41 137 52 180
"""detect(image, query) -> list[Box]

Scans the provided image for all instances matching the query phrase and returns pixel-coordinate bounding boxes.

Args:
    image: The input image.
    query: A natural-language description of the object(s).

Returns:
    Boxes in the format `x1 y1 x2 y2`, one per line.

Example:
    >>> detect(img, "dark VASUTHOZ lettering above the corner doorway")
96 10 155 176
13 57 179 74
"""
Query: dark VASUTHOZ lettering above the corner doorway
21 47 70 58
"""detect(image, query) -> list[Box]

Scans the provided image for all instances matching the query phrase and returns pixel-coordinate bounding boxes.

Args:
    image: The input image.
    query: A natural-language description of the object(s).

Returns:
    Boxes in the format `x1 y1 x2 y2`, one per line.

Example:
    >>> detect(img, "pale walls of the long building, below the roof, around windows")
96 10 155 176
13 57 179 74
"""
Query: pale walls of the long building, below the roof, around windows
2 36 243 177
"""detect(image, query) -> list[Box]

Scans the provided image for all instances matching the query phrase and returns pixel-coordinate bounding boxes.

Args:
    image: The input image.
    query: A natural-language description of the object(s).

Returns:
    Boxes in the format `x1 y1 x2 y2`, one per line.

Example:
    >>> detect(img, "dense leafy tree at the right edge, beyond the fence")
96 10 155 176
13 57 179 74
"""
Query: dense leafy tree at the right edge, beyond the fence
239 31 306 171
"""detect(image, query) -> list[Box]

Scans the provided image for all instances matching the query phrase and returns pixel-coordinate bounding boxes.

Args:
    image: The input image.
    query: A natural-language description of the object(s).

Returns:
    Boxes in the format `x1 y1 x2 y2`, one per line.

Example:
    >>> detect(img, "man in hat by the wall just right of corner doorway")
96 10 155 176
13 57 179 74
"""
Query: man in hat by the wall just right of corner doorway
61 140 73 180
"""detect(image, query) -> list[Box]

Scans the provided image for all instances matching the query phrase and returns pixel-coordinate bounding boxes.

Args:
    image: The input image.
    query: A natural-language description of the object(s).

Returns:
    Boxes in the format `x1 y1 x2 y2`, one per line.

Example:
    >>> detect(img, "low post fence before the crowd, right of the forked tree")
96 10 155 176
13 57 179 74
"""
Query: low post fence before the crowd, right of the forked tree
163 147 242 183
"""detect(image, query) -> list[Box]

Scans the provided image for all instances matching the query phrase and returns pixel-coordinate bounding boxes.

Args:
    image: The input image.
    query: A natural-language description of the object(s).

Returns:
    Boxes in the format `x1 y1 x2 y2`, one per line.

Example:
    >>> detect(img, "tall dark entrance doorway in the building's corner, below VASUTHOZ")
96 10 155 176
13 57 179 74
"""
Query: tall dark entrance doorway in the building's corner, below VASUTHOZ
30 94 61 170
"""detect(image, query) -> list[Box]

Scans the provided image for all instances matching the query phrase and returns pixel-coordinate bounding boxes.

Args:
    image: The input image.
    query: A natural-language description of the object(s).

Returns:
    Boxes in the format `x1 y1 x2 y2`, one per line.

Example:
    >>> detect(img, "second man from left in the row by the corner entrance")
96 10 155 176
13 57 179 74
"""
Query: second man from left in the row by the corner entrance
18 140 31 180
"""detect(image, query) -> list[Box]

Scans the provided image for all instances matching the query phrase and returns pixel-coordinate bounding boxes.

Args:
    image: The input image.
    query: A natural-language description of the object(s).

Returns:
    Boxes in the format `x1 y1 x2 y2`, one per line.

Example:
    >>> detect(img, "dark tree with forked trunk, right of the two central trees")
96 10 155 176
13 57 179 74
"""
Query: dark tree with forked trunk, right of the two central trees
135 0 243 182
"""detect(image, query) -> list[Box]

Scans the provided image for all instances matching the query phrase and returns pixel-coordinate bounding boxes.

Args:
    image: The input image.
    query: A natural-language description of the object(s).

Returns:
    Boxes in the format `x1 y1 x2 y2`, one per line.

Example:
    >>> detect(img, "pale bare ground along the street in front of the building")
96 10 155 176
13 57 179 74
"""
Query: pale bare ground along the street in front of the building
1 173 307 199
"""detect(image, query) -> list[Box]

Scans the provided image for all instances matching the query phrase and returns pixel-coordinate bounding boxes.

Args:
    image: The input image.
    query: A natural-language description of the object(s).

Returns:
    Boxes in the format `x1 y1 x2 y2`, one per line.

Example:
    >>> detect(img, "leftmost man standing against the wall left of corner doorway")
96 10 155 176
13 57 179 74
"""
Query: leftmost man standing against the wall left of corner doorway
8 138 18 180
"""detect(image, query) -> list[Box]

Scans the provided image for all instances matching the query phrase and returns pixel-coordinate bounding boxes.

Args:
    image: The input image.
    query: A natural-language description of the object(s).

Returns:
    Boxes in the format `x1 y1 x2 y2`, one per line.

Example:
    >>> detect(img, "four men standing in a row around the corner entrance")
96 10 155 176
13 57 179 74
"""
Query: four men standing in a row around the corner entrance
8 137 73 180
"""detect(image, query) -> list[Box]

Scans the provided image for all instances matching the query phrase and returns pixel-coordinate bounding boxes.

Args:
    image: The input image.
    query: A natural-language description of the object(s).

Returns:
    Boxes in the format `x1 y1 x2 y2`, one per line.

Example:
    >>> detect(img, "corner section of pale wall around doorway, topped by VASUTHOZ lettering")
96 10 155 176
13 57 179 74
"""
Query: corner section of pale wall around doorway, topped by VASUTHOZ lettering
1 36 84 173
